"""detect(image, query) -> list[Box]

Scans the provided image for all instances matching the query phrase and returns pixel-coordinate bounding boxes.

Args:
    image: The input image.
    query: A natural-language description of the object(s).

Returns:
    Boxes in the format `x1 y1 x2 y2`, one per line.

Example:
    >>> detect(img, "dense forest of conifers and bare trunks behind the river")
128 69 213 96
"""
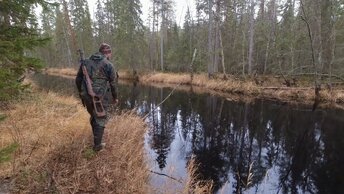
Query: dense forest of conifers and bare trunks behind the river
0 0 344 101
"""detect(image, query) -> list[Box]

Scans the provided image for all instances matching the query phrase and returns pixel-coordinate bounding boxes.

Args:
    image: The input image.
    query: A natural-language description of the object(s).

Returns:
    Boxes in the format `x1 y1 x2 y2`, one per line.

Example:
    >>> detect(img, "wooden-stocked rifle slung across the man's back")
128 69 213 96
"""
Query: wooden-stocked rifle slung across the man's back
78 49 106 117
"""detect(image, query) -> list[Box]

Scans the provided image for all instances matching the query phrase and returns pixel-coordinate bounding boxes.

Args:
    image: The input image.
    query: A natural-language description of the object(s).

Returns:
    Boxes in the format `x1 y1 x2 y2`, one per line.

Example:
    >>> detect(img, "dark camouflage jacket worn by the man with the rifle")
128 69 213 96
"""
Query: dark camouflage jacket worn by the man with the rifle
75 52 117 99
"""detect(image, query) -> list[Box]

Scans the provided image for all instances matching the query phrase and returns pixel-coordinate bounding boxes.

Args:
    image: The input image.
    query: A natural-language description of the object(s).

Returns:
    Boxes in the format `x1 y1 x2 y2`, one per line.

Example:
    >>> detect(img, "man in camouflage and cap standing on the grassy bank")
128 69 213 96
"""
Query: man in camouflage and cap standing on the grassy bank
75 43 118 151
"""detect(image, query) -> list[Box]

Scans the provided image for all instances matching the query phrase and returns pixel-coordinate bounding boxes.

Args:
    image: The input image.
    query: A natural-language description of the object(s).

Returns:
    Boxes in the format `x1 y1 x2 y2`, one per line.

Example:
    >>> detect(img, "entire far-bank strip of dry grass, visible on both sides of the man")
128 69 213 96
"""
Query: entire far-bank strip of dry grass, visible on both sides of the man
45 68 344 109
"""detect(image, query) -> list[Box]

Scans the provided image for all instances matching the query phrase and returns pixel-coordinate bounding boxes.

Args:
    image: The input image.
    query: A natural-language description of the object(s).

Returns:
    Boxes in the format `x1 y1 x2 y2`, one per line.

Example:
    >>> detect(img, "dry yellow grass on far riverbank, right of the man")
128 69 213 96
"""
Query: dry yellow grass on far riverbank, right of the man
140 73 344 104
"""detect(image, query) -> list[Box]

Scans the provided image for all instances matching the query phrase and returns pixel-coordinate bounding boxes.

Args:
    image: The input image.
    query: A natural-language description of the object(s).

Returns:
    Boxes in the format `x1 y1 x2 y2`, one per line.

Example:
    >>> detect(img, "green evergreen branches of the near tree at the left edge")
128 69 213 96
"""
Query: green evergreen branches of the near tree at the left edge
0 0 48 100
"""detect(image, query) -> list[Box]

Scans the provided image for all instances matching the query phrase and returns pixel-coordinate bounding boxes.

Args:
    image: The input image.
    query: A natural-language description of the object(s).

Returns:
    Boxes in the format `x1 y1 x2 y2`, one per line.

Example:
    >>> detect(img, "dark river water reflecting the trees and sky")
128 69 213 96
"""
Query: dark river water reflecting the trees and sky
34 74 344 193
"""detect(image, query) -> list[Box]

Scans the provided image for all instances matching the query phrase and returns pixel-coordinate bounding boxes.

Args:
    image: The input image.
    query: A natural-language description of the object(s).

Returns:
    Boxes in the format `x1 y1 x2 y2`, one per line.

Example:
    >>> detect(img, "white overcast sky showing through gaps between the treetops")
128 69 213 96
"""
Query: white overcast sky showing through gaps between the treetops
87 0 195 25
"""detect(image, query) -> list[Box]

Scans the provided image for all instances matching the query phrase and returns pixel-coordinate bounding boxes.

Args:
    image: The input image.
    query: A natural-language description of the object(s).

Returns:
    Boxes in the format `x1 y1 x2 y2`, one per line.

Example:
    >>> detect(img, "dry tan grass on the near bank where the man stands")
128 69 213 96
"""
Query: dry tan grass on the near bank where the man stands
0 80 212 193
